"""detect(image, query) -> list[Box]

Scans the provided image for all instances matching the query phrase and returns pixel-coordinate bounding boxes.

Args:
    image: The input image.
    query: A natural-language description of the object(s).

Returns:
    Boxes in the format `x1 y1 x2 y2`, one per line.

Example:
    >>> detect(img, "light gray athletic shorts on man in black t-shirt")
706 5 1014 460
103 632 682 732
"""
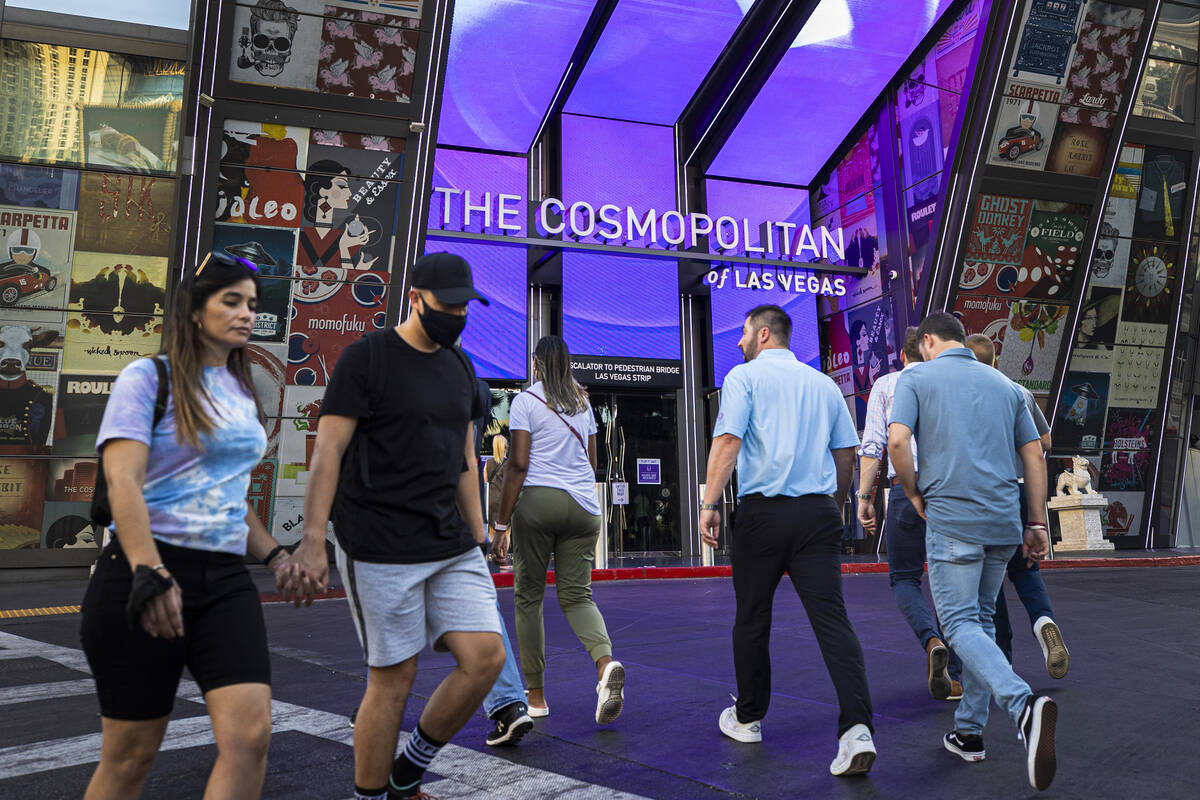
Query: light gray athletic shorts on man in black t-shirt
337 547 500 667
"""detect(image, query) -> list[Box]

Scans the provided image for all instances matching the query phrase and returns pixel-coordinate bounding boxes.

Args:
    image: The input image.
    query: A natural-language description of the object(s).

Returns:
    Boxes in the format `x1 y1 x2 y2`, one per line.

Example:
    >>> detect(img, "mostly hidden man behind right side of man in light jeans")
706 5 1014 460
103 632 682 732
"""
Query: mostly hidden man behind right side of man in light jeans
967 333 1070 678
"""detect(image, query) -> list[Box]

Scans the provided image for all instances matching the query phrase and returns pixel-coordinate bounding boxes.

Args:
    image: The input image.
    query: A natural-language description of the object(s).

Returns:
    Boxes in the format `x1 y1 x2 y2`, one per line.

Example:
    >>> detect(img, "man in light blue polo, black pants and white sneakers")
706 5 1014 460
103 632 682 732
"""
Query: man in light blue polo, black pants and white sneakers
700 306 875 775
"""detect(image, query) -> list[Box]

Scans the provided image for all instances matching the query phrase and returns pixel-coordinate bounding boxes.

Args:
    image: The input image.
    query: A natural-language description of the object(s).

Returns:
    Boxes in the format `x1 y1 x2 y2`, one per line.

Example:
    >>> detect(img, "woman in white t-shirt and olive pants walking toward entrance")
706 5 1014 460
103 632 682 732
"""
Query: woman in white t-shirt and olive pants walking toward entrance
492 336 625 724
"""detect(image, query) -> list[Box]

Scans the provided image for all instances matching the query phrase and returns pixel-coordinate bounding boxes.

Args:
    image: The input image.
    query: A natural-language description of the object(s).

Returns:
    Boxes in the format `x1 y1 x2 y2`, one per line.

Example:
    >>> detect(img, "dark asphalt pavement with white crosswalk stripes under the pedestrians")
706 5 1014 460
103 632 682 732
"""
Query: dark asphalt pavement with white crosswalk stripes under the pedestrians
0 566 1200 800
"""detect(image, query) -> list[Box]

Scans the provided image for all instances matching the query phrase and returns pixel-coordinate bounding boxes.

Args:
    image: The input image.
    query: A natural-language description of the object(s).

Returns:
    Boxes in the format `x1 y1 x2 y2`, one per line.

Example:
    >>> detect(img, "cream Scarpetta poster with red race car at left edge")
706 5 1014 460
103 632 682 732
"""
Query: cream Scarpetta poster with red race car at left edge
0 205 76 323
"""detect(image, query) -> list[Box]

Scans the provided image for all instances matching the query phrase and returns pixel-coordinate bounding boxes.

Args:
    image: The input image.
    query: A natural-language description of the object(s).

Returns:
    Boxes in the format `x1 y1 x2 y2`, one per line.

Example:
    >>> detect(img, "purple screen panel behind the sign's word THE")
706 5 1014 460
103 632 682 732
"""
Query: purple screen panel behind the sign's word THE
428 148 527 236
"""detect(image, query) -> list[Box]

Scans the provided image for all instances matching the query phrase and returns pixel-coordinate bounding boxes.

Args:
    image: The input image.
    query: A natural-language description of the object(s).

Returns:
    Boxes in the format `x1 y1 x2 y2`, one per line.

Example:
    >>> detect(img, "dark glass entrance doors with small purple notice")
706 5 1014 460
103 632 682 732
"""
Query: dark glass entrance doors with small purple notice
590 391 683 559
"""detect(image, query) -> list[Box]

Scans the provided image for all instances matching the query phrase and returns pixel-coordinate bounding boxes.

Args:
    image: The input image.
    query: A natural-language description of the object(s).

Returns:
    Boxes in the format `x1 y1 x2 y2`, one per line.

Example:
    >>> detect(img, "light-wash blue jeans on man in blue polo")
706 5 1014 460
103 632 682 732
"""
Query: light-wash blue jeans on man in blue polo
925 530 1033 735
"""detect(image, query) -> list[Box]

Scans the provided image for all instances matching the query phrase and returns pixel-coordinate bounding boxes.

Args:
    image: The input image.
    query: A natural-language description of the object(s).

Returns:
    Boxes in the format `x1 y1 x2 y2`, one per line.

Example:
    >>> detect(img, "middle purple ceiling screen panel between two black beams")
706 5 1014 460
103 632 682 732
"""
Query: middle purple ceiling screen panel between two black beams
566 0 750 125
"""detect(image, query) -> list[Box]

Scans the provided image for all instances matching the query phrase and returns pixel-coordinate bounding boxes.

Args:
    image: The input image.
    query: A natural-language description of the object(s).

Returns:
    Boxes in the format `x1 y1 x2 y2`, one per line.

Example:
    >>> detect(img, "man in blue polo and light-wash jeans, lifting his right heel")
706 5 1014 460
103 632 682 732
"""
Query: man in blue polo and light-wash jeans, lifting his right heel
888 312 1058 789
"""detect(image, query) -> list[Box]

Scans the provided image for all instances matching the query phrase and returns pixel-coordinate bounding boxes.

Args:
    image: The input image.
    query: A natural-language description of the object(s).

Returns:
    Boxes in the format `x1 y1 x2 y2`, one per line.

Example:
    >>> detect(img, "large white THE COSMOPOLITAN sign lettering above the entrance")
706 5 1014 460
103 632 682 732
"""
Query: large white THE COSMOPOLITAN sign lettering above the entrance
430 186 846 261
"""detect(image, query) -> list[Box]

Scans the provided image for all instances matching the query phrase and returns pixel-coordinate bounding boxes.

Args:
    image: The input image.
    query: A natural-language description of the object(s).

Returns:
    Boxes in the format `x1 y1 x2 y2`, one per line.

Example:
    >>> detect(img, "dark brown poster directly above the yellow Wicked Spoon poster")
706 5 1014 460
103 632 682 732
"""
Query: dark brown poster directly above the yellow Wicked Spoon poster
76 172 175 255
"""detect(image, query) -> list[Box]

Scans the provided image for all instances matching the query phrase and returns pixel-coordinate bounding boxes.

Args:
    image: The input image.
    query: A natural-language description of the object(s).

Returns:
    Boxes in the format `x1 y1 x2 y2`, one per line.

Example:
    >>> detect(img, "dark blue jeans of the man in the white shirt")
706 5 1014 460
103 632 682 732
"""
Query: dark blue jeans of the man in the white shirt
883 486 962 680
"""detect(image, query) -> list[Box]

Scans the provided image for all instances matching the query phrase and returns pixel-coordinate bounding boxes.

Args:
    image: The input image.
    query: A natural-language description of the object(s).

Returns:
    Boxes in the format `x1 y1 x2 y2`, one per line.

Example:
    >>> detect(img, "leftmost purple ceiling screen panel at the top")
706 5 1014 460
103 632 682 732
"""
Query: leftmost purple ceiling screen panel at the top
438 0 593 152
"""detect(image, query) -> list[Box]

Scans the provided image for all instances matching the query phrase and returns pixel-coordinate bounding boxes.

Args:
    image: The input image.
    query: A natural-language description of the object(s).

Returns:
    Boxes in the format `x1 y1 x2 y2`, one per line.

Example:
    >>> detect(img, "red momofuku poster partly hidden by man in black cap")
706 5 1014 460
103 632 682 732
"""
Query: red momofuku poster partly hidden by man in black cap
287 272 388 386
